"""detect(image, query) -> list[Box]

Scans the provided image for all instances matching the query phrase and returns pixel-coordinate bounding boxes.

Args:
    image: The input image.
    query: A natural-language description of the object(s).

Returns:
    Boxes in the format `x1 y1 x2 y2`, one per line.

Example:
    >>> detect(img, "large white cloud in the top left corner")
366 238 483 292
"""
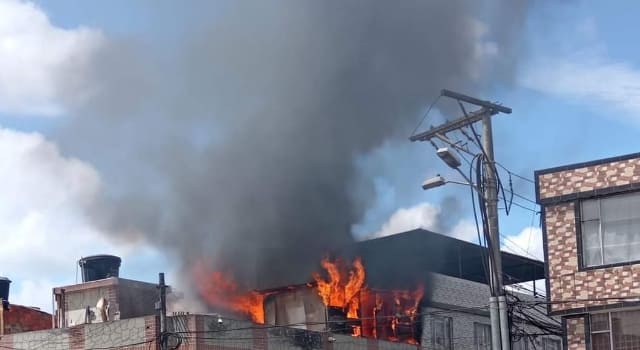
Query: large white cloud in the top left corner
0 0 103 115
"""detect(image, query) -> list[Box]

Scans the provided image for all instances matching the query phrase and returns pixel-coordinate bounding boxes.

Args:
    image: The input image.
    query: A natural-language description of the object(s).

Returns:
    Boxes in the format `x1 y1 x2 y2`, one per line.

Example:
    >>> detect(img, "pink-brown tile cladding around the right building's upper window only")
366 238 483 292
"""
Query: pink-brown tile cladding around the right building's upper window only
536 156 640 311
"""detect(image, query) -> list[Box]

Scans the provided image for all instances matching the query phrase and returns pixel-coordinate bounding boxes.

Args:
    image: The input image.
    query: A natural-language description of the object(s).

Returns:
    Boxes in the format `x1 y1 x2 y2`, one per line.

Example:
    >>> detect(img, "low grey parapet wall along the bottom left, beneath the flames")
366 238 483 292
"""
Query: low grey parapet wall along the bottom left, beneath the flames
0 314 416 350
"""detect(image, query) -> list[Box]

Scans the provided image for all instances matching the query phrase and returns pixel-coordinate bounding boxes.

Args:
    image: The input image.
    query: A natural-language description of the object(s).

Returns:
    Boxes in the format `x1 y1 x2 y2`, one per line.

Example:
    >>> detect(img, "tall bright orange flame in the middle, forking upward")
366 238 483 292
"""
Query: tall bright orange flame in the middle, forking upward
313 258 365 318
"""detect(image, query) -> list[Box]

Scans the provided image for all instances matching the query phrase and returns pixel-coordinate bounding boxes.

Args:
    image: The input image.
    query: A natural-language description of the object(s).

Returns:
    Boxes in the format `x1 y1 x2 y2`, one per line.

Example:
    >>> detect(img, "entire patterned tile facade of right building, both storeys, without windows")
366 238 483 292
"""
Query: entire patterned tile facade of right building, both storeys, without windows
536 154 640 350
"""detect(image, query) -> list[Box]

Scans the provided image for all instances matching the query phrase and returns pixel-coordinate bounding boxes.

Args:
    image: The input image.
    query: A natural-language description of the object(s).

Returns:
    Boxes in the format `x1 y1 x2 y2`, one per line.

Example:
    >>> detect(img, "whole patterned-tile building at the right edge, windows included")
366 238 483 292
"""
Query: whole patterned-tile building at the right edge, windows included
535 153 640 350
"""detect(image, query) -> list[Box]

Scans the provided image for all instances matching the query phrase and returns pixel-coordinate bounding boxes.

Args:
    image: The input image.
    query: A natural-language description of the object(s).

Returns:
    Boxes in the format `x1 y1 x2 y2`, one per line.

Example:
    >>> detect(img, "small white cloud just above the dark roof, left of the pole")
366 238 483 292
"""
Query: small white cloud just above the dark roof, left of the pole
366 202 477 242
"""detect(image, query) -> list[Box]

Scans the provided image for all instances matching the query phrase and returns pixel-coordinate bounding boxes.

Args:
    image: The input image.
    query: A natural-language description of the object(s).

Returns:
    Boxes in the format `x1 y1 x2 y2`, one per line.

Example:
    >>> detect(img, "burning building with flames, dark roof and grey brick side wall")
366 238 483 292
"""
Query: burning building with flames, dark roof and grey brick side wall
192 230 557 349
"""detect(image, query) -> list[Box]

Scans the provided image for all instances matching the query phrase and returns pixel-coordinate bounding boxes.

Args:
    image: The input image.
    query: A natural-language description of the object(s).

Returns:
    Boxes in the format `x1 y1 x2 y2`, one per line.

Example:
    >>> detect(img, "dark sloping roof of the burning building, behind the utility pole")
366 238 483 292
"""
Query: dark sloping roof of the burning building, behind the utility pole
357 229 545 286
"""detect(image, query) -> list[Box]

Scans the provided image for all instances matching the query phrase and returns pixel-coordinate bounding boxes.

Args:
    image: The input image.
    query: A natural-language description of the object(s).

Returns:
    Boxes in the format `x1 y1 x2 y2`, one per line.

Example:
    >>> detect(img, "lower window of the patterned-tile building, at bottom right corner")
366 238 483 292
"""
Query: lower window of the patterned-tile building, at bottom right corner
591 310 640 350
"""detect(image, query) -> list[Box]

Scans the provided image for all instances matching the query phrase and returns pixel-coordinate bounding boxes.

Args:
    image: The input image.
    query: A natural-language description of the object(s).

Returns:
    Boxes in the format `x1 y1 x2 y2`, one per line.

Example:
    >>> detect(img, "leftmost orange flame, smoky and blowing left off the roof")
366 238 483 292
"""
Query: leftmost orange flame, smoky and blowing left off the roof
193 262 264 323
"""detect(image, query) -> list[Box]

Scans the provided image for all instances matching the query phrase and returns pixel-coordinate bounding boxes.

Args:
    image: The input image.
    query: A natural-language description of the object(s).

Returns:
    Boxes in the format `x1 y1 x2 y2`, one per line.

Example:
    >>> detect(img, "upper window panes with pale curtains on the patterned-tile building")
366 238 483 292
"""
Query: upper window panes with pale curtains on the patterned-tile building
580 193 640 266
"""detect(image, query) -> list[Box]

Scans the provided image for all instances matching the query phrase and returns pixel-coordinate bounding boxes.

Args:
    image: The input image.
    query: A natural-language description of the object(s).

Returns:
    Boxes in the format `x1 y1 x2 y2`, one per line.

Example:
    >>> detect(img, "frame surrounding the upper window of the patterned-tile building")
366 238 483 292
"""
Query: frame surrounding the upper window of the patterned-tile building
573 190 640 271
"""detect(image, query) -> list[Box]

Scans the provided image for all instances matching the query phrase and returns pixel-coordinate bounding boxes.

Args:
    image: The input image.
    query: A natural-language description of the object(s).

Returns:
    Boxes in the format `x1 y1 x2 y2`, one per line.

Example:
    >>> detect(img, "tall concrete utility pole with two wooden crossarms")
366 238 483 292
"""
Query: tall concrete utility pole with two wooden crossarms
409 90 511 350
